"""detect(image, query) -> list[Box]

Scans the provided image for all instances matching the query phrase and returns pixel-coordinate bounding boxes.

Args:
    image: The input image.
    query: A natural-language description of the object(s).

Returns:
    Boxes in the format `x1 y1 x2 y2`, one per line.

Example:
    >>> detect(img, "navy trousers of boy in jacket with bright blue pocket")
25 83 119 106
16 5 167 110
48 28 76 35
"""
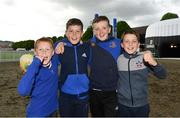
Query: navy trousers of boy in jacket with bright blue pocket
59 93 89 117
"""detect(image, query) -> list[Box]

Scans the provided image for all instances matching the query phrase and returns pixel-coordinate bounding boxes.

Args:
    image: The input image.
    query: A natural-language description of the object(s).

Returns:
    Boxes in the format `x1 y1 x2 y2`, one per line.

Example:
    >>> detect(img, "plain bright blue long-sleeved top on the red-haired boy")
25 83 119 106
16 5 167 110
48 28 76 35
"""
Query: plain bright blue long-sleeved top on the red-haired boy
18 56 58 117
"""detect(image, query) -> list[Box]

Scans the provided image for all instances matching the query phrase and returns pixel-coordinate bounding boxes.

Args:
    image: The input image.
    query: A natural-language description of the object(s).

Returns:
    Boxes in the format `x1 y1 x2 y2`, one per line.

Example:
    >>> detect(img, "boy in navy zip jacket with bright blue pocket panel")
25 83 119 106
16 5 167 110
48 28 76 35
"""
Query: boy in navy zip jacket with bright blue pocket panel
55 18 90 117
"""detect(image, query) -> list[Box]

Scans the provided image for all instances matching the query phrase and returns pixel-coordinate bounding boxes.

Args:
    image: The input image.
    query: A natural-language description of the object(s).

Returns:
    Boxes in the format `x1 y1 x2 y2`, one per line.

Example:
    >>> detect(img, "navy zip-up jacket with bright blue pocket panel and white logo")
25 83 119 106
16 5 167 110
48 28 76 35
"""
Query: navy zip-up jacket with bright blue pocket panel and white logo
58 39 90 95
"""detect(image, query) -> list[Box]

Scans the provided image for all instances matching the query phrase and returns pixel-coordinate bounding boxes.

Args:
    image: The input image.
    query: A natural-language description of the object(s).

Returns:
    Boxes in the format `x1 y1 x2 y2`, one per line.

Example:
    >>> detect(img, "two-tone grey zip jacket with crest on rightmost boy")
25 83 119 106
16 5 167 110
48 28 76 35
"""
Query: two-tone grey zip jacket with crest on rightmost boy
117 52 166 107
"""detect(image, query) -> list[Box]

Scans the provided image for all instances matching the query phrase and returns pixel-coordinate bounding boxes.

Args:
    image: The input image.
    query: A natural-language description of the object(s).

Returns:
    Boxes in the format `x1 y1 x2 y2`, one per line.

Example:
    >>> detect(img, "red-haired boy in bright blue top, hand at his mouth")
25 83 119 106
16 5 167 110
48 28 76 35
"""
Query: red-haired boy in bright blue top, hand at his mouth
18 37 58 117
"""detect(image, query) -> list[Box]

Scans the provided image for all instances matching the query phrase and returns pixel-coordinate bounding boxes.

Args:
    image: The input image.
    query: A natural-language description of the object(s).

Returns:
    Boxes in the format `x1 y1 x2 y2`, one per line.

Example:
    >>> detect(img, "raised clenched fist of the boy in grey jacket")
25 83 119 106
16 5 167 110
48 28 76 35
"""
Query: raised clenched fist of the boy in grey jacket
143 50 157 66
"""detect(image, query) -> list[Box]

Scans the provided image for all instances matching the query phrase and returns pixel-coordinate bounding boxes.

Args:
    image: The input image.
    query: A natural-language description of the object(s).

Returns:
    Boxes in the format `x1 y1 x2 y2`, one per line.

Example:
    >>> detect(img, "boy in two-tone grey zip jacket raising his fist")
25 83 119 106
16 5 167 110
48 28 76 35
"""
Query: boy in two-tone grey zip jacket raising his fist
117 31 166 117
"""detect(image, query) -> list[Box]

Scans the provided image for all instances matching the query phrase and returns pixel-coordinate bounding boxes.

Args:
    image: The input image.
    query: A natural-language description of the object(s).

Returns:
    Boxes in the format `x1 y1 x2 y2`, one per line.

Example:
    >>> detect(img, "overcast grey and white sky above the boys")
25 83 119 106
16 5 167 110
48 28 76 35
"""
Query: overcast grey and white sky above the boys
0 0 180 41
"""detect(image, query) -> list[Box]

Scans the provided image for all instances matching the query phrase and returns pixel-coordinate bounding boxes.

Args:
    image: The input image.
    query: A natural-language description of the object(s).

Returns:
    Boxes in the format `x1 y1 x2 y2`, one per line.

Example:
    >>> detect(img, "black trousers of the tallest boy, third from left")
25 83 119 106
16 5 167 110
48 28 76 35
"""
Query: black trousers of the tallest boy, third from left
90 90 117 117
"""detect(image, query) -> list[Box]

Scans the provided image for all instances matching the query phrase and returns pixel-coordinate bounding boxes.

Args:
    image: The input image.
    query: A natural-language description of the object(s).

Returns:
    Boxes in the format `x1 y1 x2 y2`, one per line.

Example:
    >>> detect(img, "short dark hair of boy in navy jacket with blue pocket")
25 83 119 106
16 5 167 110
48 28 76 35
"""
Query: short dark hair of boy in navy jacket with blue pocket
66 18 83 31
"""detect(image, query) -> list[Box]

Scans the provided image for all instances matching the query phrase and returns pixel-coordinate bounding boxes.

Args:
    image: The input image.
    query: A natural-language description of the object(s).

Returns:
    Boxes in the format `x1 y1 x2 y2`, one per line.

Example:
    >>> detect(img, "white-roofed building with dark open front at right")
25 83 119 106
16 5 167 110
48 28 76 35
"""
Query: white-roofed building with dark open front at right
145 18 180 57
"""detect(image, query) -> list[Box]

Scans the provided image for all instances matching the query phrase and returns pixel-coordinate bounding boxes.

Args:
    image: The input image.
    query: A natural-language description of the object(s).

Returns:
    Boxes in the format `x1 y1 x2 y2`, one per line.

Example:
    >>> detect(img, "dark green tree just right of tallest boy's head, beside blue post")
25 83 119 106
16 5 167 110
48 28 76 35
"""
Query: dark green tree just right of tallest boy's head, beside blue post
117 21 131 38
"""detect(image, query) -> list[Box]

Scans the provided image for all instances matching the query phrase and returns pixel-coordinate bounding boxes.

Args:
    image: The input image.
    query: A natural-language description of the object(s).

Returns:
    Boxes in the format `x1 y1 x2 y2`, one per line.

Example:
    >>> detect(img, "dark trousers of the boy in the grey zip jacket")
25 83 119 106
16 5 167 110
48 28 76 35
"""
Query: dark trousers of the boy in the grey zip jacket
118 104 150 117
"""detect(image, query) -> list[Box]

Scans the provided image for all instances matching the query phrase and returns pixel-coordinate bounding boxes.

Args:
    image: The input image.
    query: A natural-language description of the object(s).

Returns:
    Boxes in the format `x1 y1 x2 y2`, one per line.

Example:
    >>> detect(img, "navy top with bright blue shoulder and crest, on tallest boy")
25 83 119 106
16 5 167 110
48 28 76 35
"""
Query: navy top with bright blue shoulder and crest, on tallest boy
90 36 121 91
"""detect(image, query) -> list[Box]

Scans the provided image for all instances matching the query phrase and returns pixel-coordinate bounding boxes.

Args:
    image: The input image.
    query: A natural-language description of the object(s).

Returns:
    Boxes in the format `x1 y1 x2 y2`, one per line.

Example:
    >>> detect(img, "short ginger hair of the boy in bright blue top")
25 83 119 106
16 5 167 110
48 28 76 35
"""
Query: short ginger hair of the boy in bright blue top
34 37 54 50
